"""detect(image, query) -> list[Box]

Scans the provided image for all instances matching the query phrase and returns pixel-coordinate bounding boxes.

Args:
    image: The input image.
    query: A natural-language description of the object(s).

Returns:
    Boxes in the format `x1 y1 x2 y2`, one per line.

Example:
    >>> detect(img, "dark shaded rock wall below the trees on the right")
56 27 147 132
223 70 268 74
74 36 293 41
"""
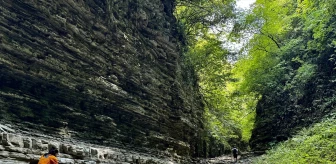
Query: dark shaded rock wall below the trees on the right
250 70 336 151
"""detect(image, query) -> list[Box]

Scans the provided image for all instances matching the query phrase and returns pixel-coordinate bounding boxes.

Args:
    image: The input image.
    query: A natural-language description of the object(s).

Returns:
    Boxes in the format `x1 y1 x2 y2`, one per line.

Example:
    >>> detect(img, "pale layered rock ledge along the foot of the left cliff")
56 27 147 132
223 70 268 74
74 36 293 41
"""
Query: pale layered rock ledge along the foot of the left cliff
0 125 186 164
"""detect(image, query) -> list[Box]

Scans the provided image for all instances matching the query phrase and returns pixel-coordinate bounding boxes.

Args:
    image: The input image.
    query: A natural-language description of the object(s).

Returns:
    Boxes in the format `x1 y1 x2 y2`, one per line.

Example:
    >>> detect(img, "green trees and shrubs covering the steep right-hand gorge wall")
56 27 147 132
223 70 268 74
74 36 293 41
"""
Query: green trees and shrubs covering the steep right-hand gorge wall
233 0 336 148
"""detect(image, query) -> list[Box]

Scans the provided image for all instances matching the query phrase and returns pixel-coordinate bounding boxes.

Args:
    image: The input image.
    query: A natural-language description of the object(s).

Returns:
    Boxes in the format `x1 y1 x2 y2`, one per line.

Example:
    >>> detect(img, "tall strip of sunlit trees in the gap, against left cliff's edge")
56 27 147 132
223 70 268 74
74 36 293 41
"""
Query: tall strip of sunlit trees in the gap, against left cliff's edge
175 0 258 150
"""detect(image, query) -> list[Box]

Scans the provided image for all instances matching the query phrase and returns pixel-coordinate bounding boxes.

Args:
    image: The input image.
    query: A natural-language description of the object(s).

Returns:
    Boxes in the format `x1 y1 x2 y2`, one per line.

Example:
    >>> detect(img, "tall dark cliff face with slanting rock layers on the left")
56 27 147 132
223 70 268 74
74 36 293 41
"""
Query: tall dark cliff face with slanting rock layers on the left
0 0 203 160
